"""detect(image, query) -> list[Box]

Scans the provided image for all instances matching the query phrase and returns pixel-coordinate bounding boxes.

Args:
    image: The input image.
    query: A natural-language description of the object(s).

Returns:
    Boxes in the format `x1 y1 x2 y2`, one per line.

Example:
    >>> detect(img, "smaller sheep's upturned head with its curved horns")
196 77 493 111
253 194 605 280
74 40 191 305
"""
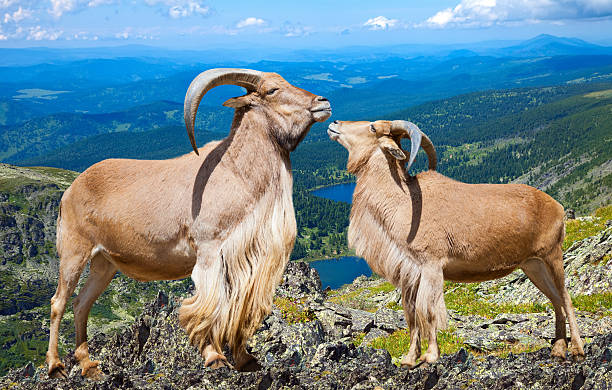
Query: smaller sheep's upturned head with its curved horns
327 121 437 173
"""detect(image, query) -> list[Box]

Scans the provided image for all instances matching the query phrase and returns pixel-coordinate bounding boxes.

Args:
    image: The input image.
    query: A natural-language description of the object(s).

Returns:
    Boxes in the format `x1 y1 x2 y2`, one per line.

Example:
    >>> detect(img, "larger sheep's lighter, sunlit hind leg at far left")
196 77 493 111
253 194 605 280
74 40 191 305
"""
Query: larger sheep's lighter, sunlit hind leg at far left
46 240 91 378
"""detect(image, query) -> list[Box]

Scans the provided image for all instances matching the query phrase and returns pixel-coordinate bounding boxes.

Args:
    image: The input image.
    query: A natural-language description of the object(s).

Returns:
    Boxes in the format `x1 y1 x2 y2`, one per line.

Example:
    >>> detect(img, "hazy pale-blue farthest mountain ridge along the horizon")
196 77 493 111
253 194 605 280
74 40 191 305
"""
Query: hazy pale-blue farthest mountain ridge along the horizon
0 34 612 66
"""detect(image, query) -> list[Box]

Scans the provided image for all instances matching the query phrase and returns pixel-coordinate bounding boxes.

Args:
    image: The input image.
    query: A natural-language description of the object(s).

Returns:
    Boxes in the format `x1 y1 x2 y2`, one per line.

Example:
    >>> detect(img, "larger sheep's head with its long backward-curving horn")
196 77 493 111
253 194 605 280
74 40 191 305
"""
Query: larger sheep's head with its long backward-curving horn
185 68 331 154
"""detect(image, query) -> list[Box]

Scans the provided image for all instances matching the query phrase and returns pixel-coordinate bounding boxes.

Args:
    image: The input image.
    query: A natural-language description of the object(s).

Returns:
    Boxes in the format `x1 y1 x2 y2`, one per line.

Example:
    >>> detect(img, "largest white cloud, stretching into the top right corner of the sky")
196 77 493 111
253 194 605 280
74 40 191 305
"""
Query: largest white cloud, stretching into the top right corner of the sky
426 0 612 28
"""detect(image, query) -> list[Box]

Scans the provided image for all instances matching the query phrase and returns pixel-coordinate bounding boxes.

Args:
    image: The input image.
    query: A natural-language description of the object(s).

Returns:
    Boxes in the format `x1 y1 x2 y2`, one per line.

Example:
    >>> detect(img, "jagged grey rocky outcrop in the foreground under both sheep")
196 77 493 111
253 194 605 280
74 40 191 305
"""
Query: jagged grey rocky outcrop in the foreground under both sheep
0 263 612 389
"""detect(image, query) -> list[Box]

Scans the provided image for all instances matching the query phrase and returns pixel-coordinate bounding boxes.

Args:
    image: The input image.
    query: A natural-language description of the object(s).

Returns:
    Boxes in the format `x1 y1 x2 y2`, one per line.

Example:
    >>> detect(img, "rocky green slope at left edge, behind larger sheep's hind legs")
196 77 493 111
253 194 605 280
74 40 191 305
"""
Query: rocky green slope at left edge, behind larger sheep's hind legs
0 164 190 373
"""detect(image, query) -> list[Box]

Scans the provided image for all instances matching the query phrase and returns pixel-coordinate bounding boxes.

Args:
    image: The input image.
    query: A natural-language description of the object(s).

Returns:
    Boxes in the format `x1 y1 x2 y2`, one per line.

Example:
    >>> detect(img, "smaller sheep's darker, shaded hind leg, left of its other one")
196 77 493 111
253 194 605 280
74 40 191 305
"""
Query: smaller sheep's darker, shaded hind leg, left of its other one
521 259 567 360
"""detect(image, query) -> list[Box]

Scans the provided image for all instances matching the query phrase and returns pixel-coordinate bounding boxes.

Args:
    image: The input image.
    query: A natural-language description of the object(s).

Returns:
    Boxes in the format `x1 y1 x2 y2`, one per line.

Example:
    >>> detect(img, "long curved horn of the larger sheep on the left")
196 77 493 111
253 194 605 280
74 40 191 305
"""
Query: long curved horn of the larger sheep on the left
184 68 263 155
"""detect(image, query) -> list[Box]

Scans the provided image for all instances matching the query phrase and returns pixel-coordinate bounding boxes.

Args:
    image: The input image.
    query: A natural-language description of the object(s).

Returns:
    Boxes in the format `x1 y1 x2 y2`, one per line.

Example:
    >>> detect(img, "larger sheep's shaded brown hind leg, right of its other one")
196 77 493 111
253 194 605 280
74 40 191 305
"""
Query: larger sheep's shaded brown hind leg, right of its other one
73 254 117 379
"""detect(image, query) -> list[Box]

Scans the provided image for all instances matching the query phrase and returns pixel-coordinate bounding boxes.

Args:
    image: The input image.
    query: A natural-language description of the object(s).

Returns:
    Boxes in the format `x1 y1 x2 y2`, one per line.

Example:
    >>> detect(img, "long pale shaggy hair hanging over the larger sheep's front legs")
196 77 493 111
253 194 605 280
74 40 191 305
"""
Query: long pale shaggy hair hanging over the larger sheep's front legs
179 198 295 370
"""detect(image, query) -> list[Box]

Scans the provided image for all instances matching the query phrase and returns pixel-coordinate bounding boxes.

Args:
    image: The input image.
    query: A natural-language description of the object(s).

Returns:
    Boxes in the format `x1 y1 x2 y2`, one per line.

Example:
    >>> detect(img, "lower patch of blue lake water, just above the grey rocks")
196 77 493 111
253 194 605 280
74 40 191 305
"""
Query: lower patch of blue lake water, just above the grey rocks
310 256 372 289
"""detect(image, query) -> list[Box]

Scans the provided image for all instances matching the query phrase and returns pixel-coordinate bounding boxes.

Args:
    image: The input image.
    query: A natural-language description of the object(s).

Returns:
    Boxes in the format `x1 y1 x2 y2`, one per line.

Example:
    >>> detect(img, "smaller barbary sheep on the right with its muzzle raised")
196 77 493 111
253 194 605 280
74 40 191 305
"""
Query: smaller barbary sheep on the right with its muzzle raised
328 121 584 367
